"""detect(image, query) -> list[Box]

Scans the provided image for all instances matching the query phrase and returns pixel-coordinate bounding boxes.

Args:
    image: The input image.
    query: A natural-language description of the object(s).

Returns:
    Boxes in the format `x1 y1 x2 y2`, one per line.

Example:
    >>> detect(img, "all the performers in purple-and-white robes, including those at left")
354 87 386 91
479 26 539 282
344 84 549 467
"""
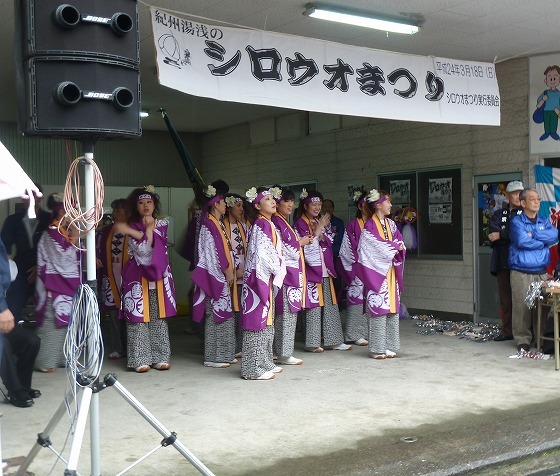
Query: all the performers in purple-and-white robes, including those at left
38 180 406 380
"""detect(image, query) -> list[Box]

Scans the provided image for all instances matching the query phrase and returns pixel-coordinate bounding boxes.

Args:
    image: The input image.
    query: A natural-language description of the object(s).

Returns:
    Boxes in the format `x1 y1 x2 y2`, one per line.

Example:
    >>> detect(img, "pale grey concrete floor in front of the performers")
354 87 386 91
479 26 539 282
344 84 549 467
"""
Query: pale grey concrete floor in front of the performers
0 318 560 476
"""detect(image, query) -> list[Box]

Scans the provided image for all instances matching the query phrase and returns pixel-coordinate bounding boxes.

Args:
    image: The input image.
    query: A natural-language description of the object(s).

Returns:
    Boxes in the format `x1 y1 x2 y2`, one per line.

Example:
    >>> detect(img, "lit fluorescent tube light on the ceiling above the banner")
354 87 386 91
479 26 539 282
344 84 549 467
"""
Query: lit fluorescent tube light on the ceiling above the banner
303 3 419 35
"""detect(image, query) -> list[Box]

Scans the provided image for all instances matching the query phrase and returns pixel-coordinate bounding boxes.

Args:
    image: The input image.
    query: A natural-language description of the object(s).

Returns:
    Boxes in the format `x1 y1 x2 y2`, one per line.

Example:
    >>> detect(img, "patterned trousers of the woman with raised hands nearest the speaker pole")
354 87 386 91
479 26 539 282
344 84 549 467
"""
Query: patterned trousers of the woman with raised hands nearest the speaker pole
126 289 171 369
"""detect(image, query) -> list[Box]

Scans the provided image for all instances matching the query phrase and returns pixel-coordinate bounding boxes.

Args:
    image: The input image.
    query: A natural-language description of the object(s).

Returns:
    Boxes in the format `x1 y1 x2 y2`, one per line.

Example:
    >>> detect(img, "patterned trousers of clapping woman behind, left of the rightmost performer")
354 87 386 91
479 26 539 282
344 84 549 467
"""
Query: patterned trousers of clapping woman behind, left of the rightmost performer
305 278 343 348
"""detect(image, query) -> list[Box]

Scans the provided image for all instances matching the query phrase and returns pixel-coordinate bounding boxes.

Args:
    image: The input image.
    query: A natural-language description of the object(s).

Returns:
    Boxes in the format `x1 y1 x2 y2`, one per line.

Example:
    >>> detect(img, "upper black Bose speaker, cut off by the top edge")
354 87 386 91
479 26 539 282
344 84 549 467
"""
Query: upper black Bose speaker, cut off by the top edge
22 0 140 65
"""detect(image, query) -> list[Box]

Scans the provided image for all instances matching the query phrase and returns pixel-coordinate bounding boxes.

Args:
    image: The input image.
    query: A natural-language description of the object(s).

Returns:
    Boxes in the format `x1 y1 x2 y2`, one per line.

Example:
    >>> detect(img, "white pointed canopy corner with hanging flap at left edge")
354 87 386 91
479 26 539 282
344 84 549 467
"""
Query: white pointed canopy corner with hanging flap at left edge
0 142 43 218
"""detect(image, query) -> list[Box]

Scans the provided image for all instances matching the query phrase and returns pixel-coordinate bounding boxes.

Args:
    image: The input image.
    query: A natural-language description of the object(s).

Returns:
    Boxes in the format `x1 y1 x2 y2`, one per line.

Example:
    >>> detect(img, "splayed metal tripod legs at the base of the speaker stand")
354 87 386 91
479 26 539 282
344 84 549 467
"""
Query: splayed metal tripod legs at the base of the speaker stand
17 373 214 476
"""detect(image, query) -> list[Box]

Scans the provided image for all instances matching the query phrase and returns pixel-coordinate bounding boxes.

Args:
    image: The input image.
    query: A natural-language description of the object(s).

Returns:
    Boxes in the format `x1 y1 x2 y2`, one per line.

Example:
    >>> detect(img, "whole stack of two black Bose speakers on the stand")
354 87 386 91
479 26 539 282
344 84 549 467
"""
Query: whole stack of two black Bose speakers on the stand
14 0 142 139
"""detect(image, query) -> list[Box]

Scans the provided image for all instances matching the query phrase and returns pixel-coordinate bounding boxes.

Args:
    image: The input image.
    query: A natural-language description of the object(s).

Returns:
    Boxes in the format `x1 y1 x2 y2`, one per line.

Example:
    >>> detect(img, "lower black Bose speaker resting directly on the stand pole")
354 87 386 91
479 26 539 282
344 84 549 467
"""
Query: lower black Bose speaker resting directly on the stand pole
21 56 141 138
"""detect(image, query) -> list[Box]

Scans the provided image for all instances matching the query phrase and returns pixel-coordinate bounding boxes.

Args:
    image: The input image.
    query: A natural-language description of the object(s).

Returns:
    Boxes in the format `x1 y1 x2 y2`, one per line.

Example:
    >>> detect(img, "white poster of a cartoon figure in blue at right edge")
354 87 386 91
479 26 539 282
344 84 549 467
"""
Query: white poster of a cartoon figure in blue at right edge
528 53 560 154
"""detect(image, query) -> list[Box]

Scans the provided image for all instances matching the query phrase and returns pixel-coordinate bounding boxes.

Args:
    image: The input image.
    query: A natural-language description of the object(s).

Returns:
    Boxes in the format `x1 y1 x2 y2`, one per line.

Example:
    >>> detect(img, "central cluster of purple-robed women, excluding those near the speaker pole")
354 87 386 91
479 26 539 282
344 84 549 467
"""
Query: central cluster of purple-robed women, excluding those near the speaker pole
191 180 406 380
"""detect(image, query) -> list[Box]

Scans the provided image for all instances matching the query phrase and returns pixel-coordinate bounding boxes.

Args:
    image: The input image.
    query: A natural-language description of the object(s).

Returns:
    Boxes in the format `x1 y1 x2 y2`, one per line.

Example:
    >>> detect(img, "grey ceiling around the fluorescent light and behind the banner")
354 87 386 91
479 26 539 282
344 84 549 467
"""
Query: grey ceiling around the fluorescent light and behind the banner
0 0 560 132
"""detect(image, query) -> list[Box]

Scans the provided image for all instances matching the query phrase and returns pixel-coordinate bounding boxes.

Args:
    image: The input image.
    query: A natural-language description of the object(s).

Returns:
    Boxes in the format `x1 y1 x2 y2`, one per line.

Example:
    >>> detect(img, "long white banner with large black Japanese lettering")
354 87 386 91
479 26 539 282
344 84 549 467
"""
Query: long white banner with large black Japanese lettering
150 7 500 126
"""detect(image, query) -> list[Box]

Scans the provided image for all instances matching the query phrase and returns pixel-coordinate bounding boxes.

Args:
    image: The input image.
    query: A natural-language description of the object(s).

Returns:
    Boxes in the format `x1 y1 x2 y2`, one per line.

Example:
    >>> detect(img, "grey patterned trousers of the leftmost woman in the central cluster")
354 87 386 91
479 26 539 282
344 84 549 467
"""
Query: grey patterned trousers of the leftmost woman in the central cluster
204 298 235 364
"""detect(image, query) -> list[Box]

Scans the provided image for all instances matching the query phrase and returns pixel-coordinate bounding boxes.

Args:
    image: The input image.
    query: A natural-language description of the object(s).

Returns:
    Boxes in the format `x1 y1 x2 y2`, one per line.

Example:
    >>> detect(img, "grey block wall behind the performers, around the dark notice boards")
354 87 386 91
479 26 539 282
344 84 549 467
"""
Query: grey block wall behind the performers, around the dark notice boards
199 59 538 317
